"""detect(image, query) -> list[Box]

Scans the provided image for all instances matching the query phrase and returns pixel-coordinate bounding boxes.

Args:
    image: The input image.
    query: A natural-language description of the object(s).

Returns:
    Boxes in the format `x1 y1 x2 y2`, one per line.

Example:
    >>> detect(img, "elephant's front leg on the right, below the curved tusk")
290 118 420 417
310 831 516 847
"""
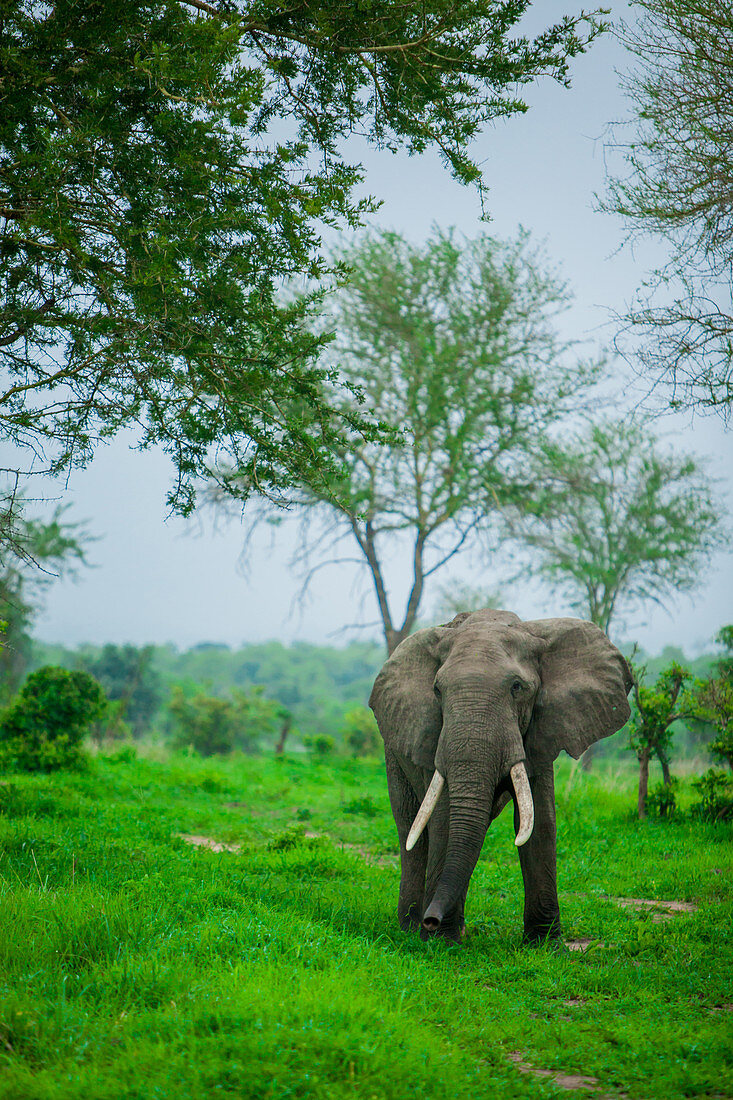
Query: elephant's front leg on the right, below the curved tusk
514 765 560 944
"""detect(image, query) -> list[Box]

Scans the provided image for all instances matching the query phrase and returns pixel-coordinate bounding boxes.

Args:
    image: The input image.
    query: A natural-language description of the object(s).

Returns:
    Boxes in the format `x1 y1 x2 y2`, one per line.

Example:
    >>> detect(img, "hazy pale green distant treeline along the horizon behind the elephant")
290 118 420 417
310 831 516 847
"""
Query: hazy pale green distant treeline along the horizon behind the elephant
31 641 715 754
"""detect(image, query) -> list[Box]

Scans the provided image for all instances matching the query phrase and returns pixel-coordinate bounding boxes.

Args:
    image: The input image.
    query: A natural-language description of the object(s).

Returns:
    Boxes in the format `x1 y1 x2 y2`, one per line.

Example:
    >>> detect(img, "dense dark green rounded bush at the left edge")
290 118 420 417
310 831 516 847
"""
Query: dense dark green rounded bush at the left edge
0 666 107 771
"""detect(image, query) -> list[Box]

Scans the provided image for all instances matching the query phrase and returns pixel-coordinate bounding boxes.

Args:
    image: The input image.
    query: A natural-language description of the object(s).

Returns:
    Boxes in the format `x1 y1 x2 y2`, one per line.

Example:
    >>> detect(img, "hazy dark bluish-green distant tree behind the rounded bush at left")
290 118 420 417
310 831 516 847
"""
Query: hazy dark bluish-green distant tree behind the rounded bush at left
78 645 163 737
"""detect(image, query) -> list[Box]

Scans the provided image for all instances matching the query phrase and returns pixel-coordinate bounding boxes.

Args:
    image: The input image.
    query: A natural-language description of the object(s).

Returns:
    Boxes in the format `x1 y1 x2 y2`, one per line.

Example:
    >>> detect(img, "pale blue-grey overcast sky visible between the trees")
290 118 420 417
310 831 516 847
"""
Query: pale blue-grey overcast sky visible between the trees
36 0 733 652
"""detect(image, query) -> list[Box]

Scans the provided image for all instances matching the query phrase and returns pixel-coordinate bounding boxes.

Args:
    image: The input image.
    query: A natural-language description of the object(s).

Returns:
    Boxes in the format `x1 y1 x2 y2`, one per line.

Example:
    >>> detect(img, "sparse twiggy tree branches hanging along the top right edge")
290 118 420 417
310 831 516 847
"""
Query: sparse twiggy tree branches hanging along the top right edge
603 0 733 418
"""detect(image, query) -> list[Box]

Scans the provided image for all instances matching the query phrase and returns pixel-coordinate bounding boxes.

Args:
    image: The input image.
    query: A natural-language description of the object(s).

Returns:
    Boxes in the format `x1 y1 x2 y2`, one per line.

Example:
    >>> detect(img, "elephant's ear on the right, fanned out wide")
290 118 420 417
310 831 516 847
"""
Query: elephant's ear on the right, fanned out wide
522 618 632 767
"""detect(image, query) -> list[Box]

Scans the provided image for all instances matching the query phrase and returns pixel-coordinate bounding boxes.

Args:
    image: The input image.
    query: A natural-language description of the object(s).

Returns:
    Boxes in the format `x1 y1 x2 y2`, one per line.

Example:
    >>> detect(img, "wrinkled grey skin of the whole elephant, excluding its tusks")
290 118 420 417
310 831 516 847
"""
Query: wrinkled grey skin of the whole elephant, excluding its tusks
370 611 631 943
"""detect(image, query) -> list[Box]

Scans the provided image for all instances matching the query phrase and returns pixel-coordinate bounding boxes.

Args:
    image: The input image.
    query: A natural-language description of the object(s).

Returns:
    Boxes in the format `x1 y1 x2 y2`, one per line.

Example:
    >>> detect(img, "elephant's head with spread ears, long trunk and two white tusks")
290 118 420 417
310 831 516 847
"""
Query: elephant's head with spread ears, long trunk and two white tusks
370 611 631 931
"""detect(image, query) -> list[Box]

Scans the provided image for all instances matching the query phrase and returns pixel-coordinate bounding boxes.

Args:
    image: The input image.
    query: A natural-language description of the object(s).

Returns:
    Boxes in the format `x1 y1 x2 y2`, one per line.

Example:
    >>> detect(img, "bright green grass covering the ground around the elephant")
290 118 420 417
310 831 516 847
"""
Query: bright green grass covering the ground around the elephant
0 756 733 1100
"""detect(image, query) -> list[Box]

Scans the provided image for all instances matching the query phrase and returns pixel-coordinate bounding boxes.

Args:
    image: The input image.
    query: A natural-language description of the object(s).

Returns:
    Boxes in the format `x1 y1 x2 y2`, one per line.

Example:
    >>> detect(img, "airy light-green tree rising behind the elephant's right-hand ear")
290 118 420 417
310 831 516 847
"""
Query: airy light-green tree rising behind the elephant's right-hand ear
499 419 724 634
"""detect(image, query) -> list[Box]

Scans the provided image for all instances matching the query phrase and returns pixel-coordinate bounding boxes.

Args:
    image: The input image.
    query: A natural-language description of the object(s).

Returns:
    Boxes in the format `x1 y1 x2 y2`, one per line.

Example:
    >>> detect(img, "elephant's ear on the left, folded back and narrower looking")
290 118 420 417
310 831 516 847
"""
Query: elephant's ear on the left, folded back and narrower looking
369 627 450 769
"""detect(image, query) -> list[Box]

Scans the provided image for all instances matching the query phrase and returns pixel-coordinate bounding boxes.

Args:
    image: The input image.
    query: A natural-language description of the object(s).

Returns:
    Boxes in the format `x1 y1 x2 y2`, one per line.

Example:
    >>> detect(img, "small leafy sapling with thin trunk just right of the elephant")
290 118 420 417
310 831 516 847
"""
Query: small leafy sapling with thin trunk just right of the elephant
628 662 690 821
